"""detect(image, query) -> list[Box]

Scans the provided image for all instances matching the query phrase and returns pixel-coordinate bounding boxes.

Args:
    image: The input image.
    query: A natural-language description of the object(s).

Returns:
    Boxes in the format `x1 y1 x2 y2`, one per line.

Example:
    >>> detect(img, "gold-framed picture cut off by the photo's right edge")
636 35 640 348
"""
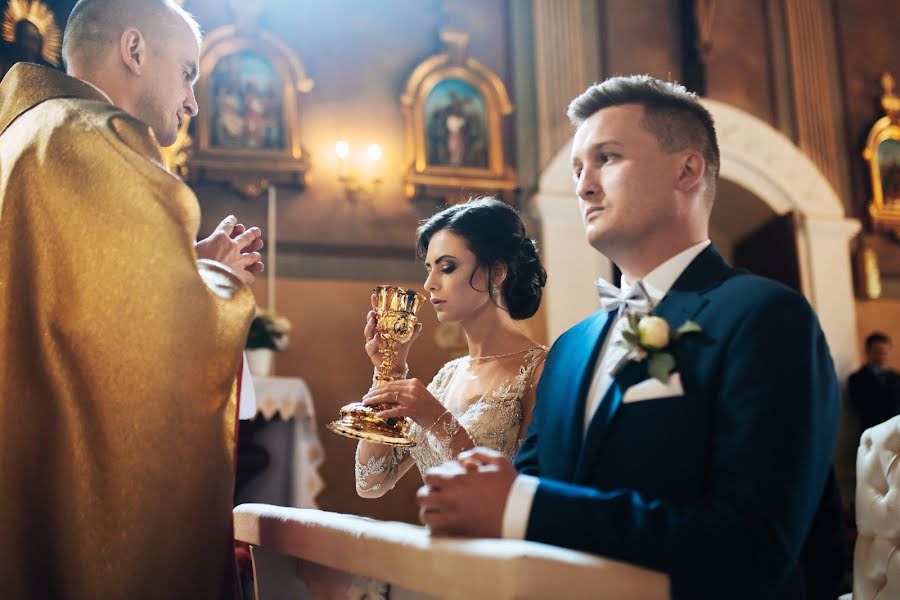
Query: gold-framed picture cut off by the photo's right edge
863 73 900 236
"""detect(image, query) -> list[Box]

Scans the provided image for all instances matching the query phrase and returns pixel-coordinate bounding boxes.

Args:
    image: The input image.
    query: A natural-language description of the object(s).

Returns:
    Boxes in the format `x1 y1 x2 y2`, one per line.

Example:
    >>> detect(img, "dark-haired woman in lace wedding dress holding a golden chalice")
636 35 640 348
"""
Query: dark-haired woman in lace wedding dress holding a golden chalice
356 198 547 498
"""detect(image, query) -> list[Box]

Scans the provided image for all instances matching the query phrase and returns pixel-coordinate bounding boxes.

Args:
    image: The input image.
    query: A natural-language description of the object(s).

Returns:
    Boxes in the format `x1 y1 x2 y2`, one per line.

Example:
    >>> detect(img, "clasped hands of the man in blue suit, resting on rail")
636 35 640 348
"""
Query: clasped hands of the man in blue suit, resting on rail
416 448 516 537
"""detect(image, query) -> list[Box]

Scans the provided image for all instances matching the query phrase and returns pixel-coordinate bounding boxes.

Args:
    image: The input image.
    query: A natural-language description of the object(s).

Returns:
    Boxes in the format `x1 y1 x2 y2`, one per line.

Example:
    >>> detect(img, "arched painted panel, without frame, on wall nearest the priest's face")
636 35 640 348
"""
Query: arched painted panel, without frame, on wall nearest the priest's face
209 50 284 149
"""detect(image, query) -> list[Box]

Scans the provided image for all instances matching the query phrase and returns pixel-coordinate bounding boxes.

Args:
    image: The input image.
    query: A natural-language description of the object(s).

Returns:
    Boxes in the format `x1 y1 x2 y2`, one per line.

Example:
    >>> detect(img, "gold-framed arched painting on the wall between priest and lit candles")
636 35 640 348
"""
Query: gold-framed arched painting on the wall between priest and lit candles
184 25 313 198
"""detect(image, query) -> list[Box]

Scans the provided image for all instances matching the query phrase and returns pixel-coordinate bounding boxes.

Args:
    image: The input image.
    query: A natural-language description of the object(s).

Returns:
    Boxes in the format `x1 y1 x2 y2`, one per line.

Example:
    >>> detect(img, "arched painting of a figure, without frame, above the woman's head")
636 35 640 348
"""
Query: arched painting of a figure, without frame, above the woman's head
425 78 488 169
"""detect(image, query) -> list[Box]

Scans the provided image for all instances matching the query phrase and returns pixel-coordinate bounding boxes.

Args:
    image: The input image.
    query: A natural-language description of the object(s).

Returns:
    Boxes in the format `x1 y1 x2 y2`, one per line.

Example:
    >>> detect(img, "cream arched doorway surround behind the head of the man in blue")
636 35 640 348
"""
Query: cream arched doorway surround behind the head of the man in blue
535 99 860 380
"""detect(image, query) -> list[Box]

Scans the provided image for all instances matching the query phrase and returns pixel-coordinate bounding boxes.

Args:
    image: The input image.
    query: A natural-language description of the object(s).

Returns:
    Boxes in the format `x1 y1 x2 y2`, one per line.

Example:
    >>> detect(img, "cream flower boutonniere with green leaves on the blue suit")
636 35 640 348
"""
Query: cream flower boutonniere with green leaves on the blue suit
618 312 703 383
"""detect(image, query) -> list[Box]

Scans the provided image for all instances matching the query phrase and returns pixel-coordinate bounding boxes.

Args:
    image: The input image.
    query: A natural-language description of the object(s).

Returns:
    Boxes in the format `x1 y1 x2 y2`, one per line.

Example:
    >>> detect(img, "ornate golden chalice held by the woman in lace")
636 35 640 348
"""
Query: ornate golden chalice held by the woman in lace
328 285 425 446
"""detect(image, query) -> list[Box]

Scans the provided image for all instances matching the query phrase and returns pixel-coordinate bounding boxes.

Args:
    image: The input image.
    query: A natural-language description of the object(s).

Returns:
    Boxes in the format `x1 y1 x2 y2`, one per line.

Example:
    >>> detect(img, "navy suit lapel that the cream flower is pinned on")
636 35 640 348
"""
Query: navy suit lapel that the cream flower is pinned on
574 246 733 482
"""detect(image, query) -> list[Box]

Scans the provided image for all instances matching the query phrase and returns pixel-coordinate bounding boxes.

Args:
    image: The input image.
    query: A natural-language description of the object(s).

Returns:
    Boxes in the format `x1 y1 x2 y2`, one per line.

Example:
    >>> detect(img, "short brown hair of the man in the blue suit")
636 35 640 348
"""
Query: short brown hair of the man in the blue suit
567 75 719 190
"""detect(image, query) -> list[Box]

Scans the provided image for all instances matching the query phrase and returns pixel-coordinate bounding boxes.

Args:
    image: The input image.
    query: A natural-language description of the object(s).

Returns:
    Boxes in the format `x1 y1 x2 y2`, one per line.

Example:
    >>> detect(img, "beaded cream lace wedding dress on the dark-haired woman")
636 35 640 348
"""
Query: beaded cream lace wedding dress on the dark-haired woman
356 346 547 498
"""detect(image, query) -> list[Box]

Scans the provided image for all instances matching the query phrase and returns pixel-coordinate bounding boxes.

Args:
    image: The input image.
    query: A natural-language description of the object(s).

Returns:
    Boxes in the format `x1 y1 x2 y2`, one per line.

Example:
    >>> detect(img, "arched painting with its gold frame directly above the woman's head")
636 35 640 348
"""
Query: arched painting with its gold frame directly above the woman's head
400 29 518 203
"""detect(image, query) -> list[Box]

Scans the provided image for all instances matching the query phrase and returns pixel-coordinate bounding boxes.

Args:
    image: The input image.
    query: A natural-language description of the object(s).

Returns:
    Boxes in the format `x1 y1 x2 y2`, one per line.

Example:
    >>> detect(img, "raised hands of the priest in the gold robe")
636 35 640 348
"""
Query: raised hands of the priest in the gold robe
194 215 265 285
